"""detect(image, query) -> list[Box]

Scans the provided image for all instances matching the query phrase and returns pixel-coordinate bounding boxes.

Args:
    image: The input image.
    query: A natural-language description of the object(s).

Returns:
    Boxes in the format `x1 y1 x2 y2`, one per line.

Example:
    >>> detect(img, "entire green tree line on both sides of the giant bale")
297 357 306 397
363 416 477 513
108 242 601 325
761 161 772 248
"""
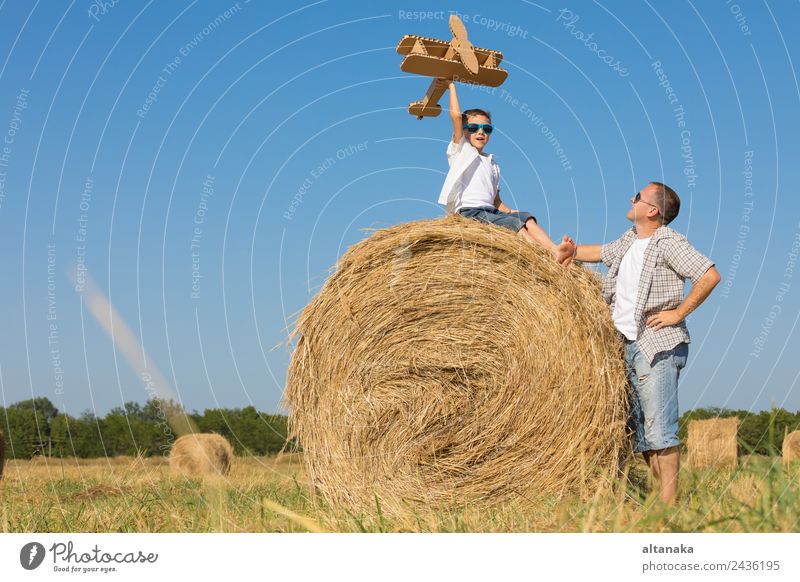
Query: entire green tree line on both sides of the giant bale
0 398 800 459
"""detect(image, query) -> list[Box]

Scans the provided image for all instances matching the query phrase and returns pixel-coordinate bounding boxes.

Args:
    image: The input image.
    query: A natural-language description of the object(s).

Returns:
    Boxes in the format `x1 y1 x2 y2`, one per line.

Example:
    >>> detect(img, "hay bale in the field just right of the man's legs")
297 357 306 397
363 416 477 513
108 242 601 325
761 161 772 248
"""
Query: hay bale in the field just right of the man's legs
686 417 739 469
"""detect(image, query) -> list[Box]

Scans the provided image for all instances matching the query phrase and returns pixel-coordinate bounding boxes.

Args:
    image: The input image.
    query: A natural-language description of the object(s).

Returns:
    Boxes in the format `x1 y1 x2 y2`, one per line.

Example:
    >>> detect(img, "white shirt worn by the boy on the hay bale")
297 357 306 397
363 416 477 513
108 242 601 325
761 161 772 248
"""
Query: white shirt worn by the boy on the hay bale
439 136 500 214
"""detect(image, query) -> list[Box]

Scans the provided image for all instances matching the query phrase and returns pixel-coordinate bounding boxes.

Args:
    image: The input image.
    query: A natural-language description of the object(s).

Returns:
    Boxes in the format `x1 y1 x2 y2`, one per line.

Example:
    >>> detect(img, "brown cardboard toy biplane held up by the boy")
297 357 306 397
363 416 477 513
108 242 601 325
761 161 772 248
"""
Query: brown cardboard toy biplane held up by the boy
397 14 508 119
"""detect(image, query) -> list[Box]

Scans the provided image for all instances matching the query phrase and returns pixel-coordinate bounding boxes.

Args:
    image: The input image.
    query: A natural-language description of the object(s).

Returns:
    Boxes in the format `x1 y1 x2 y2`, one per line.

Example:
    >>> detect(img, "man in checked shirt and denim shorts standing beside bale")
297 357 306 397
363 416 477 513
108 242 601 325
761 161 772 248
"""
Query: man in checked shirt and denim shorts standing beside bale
575 182 720 503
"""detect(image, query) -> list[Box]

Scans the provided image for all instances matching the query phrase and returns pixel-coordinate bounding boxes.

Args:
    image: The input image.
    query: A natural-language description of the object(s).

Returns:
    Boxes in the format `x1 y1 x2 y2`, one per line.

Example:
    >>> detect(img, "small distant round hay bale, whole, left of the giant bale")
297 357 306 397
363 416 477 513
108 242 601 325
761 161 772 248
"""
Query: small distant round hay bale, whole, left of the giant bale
169 433 233 477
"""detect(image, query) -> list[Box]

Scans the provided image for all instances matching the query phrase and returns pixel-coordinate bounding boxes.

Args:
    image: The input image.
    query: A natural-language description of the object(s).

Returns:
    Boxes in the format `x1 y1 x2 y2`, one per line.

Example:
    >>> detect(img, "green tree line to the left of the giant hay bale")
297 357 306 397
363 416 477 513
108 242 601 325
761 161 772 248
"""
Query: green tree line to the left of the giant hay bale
0 397 289 459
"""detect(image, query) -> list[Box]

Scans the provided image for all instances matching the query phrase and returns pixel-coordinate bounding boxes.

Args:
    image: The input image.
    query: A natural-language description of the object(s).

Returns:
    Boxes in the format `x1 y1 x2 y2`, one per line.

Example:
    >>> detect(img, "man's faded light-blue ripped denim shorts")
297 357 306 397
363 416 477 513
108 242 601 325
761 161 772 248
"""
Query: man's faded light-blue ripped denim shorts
625 340 689 453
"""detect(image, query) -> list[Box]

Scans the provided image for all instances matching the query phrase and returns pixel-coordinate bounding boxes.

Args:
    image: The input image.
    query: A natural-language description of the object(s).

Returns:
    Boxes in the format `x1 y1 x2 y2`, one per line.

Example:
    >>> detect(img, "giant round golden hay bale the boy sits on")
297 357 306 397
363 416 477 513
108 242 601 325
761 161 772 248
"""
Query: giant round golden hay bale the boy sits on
284 216 628 513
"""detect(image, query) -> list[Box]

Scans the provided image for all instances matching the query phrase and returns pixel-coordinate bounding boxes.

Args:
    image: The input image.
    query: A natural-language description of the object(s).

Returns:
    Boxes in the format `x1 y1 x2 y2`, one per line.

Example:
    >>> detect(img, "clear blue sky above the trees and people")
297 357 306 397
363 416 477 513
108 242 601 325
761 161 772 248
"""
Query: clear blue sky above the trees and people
0 0 800 414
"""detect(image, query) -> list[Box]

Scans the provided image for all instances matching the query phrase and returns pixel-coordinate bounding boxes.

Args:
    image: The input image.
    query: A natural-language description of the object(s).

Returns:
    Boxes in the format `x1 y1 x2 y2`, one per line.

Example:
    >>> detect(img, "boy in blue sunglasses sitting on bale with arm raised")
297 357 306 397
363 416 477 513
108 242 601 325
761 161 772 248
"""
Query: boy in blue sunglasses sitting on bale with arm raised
439 79 575 265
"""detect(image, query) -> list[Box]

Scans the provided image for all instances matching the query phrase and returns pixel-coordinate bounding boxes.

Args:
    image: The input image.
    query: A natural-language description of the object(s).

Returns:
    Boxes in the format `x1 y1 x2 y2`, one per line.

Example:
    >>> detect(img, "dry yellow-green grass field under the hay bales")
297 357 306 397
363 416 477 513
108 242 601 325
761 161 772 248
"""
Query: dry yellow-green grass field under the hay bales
0 455 800 532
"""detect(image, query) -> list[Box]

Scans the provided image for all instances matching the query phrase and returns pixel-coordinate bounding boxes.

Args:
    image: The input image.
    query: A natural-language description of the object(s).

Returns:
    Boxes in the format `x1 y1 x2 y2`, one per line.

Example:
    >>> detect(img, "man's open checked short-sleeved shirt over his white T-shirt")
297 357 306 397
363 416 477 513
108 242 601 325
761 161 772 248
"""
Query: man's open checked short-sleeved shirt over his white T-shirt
600 226 714 362
